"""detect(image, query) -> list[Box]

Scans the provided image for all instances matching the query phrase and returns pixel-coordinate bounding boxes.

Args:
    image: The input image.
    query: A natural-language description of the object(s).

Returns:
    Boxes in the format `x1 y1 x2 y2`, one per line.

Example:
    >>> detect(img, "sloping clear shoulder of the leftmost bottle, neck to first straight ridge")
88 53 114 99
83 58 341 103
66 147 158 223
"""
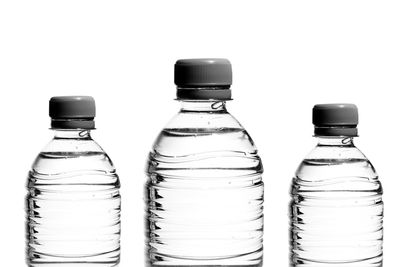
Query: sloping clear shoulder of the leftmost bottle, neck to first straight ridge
29 138 119 184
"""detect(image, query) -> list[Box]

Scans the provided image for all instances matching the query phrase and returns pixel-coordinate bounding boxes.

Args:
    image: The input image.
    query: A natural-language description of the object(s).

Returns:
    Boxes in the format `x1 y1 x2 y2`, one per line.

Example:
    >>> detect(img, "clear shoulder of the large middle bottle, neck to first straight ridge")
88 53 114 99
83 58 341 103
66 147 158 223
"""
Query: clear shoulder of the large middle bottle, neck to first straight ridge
147 112 262 177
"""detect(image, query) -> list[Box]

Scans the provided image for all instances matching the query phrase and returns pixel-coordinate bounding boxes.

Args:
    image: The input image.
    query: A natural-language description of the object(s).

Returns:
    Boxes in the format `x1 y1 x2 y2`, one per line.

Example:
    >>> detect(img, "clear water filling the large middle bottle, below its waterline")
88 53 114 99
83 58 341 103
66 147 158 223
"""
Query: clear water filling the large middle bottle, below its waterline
146 128 263 266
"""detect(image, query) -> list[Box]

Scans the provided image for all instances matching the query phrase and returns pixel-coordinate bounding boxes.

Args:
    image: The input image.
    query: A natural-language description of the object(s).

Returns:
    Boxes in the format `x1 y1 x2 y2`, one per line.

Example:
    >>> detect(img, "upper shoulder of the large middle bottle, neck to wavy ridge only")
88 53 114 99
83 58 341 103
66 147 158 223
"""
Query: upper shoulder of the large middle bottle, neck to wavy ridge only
152 111 257 156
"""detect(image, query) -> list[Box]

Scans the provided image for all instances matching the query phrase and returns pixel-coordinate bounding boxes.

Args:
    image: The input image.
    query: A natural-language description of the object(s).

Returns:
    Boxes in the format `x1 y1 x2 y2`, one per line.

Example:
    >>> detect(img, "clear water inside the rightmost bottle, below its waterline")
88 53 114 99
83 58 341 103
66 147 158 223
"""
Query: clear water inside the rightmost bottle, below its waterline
291 159 383 267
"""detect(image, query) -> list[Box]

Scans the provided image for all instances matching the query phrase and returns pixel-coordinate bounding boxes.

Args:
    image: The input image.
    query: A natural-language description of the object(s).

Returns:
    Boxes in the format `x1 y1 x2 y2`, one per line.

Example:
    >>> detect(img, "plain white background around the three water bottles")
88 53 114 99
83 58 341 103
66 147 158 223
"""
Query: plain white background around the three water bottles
0 0 400 267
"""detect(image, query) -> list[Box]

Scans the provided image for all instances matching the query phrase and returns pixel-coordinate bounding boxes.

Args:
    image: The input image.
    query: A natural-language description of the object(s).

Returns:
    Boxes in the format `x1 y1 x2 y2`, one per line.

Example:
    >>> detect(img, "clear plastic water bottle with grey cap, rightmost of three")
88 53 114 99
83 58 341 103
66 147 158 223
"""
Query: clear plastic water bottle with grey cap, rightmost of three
290 104 383 267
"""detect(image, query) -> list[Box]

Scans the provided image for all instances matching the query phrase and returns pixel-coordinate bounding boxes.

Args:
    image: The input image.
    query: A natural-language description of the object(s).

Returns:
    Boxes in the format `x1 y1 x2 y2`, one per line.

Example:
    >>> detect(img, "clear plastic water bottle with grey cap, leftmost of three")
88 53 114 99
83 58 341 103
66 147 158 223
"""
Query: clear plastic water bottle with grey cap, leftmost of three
26 96 120 267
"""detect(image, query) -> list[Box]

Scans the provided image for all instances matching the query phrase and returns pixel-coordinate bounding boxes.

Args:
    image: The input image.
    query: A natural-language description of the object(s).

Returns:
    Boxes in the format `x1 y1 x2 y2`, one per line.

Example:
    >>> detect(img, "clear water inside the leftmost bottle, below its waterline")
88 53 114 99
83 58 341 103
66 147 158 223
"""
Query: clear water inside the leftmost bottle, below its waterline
27 152 120 267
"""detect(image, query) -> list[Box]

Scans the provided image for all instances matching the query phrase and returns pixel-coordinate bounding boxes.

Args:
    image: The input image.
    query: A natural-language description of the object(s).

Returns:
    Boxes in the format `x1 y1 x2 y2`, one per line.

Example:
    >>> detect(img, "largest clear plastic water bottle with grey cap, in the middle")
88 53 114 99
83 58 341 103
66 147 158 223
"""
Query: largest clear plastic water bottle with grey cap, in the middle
146 59 263 267
